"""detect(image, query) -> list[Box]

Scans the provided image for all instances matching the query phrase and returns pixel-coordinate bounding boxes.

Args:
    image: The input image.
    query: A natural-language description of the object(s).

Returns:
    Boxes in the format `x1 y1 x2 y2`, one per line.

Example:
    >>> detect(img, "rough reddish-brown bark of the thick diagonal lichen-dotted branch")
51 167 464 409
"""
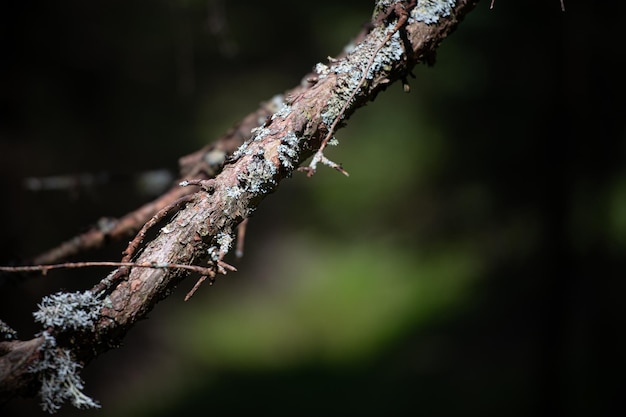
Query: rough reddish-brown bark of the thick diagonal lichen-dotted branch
0 0 475 408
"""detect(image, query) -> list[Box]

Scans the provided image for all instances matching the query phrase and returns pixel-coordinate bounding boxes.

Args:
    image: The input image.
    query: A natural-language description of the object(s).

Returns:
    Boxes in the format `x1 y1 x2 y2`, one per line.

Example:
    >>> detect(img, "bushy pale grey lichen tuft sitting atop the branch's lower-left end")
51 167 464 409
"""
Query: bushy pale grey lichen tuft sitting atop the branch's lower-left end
33 291 102 330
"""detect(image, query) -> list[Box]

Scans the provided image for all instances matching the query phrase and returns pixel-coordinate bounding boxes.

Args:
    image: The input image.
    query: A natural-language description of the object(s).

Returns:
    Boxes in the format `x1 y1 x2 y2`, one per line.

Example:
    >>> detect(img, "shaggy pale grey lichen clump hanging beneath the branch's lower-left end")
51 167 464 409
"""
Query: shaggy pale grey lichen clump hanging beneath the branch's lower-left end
29 331 100 414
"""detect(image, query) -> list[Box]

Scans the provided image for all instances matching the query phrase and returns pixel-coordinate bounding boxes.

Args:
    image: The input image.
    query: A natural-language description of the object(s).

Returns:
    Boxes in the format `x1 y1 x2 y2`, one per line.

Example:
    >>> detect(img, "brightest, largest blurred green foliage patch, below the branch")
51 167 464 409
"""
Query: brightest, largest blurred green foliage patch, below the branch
174 235 480 369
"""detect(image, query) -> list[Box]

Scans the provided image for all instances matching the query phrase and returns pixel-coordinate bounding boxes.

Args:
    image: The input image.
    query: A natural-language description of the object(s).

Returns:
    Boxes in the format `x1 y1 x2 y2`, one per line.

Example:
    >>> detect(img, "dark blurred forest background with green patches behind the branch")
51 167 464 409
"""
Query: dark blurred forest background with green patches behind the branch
0 0 626 417
